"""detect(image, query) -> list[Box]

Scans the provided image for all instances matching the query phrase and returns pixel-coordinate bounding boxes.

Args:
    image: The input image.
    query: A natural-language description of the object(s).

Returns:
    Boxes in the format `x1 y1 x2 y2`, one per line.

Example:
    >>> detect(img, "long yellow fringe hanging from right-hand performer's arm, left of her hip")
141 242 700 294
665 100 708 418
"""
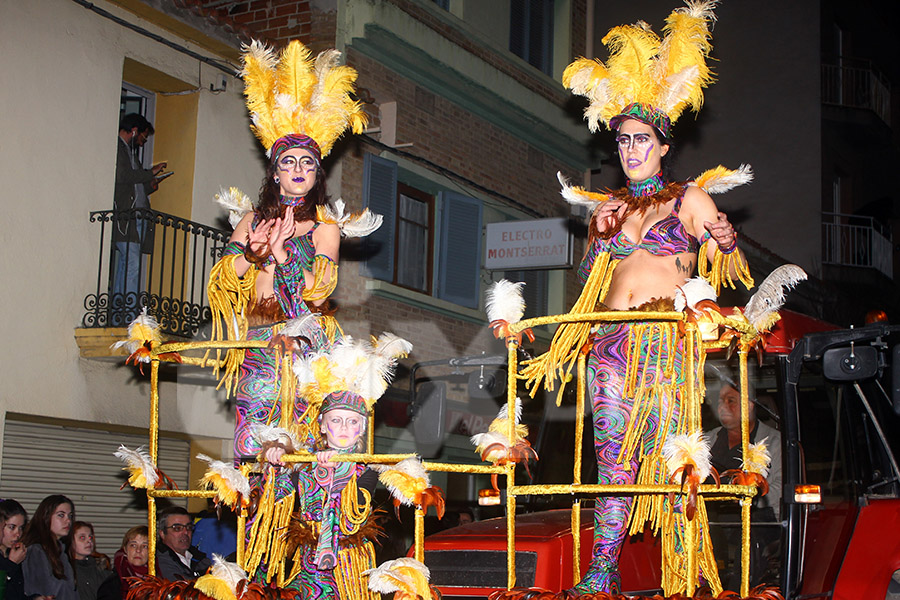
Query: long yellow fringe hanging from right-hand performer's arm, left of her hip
518 252 619 398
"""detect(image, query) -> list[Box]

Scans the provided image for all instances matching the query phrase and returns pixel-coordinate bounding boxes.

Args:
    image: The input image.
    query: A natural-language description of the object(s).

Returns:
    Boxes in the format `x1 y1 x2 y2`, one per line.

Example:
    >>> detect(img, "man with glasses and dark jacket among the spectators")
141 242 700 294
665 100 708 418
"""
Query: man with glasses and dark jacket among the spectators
156 506 212 581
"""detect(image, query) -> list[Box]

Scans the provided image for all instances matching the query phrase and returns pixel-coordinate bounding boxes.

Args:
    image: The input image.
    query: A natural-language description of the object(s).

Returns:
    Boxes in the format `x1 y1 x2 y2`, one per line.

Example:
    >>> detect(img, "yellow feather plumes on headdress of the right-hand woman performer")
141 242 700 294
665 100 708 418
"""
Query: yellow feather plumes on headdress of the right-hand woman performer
563 0 716 137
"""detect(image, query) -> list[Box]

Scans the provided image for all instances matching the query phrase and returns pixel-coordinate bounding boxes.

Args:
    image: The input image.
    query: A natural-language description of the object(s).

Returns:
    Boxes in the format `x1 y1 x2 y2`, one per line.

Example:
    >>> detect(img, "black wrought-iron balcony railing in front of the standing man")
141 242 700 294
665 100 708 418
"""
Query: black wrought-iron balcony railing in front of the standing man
81 209 229 337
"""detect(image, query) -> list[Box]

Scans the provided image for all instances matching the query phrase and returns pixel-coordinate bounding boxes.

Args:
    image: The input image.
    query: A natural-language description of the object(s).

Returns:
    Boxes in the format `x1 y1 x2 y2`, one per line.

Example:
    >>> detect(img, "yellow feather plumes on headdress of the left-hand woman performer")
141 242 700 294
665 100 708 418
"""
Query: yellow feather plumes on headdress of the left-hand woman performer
241 40 366 157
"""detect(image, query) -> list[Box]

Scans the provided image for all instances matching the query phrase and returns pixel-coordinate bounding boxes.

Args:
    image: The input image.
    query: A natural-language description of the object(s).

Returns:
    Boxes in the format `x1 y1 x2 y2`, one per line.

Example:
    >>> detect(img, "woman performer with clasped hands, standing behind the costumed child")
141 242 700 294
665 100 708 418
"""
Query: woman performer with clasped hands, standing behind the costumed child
208 41 380 580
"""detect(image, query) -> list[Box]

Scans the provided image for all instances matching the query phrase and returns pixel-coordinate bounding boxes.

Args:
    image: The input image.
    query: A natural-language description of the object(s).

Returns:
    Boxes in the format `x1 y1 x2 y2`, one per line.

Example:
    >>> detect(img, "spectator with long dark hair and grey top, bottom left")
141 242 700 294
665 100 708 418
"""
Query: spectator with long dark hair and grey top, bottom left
22 494 78 600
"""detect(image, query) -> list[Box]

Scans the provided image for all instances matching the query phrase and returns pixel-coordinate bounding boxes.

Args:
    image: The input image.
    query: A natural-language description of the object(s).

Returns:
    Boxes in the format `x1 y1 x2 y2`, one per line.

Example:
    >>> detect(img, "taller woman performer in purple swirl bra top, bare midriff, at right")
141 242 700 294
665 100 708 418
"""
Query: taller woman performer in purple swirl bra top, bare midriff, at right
523 1 752 594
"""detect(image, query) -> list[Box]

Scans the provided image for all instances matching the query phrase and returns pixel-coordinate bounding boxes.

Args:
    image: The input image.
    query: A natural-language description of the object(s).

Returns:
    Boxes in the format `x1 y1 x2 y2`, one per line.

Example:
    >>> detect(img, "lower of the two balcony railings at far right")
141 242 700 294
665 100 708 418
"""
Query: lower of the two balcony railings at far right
822 213 894 279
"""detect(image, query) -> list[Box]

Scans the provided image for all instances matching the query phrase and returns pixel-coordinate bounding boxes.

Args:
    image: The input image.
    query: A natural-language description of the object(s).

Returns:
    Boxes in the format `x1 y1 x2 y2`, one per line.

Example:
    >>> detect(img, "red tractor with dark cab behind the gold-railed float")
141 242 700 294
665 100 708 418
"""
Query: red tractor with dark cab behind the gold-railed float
414 311 900 600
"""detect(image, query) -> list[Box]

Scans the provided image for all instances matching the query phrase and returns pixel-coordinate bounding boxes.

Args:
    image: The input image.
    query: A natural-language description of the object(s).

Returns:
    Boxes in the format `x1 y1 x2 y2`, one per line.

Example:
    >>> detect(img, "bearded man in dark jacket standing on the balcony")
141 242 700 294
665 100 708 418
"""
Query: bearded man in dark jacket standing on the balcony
110 113 166 318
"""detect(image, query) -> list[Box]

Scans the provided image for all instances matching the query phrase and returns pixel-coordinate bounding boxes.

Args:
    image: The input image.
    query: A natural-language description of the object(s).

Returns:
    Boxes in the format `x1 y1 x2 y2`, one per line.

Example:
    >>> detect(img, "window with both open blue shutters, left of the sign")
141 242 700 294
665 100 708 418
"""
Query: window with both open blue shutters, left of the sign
363 154 482 309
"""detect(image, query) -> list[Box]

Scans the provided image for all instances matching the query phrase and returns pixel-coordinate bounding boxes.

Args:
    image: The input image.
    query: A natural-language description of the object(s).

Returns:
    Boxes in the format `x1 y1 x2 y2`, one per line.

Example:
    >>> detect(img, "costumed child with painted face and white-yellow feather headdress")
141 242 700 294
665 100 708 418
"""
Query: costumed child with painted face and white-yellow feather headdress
251 334 412 600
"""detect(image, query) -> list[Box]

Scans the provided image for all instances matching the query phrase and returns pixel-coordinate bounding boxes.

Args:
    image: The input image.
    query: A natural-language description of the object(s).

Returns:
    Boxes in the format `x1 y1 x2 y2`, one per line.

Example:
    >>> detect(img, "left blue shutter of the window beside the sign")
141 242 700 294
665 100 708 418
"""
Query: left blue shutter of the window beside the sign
362 153 397 281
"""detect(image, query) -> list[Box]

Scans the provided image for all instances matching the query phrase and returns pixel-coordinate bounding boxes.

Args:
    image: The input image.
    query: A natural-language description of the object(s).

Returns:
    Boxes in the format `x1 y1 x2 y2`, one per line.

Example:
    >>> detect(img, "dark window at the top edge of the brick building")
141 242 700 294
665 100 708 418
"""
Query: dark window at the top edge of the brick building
509 0 553 75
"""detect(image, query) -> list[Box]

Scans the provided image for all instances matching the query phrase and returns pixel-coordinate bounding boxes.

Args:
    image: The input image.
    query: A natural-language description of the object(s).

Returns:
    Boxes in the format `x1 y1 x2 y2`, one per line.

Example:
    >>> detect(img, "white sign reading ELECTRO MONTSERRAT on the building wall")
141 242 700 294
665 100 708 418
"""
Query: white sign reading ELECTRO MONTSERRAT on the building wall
484 218 572 271
